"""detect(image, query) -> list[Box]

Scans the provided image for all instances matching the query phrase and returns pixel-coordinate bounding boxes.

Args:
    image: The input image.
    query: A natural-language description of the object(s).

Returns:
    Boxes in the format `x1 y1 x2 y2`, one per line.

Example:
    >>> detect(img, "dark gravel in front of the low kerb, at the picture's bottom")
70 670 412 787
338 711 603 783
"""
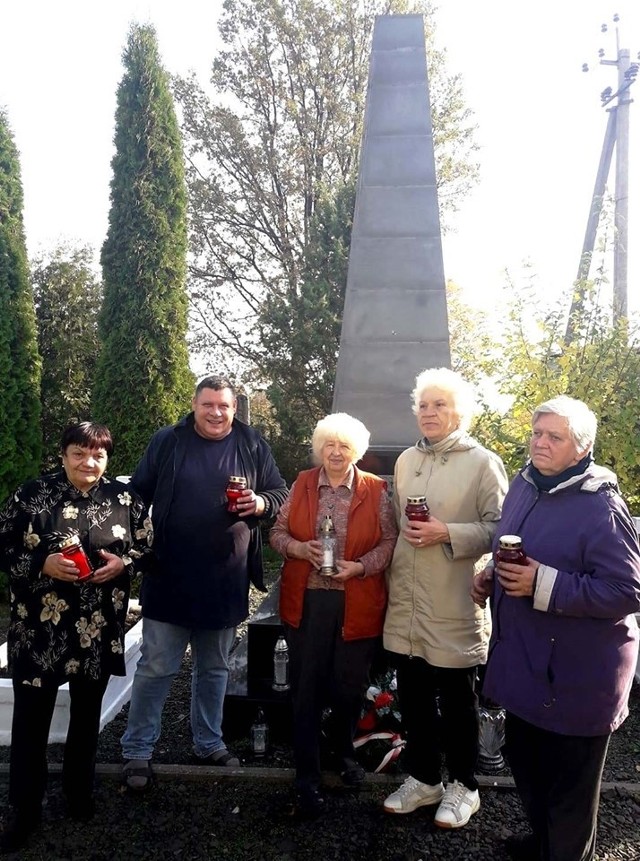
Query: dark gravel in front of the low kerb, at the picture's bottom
0 778 640 861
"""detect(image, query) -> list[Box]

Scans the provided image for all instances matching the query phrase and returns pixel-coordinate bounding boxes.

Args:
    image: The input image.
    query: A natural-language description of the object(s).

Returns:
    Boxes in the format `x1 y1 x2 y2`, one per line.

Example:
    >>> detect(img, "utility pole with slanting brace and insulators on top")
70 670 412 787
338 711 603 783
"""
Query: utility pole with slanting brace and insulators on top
565 15 640 344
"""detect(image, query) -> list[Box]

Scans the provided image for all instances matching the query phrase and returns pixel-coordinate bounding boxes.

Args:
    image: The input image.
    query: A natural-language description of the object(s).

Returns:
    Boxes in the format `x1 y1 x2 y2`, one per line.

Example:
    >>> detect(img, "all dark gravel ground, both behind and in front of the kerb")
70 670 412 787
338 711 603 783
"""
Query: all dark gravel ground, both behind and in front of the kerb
0 596 640 861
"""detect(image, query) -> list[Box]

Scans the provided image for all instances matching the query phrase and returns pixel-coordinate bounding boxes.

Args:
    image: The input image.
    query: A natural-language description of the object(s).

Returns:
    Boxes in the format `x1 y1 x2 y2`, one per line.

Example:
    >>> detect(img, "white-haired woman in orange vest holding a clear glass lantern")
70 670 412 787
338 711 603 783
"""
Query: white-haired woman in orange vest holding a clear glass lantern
270 413 397 815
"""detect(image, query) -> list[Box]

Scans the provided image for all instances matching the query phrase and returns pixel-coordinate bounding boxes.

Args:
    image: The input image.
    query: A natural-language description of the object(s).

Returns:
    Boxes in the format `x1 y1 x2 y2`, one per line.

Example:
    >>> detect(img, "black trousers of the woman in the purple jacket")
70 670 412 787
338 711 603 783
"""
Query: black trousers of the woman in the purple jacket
505 712 610 861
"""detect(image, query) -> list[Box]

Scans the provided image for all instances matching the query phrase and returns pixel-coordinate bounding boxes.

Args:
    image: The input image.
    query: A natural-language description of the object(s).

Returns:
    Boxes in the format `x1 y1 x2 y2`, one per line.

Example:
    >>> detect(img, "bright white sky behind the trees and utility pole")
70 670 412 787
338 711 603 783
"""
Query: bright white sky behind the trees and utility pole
0 0 640 310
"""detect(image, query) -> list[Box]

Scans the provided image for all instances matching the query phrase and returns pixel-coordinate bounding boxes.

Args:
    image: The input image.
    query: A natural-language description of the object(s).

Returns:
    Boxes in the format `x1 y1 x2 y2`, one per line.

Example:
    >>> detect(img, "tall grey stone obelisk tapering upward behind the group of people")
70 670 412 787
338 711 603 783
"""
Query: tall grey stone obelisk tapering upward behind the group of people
333 15 450 474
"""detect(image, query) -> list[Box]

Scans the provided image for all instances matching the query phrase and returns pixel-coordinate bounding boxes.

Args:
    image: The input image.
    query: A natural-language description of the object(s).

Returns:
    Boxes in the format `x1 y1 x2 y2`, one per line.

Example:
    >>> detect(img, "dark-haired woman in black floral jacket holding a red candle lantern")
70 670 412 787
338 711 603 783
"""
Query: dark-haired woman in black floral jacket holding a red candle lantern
0 422 150 851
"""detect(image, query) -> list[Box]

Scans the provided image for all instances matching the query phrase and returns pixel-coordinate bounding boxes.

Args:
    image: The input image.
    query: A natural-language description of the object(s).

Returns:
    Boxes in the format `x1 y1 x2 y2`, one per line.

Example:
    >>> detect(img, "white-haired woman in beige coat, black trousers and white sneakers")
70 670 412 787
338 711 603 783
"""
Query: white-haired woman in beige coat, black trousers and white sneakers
384 368 508 828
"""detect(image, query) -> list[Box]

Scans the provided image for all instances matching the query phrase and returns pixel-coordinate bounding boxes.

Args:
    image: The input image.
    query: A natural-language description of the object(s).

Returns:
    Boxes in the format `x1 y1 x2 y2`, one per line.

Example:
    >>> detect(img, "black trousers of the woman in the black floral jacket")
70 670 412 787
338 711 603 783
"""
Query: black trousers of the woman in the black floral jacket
9 676 109 816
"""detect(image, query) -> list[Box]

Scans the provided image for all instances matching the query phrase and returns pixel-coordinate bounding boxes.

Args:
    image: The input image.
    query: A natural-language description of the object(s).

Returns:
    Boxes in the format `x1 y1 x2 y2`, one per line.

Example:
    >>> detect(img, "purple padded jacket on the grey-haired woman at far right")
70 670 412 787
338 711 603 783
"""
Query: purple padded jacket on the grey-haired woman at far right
483 464 640 736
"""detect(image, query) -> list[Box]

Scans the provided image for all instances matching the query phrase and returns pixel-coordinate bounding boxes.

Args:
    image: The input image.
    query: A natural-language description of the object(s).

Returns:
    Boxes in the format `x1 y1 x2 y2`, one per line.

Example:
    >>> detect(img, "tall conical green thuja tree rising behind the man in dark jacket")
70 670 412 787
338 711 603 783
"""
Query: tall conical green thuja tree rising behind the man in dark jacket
93 25 193 471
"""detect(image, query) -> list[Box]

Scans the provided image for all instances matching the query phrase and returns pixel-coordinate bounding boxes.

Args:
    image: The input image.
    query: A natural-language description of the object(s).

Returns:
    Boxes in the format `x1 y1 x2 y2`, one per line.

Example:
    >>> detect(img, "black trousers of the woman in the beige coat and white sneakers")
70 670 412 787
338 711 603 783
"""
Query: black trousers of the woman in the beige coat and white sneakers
390 653 478 789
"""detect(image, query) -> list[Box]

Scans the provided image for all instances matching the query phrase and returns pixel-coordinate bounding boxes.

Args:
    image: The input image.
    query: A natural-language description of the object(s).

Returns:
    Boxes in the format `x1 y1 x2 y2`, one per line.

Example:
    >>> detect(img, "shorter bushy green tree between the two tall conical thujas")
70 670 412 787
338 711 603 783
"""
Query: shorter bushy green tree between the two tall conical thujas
32 244 102 469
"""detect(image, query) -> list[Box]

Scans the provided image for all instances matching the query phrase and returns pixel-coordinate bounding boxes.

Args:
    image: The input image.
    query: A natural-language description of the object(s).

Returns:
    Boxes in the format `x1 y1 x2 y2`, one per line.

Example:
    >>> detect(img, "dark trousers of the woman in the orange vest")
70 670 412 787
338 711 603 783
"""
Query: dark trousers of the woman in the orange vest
286 589 376 788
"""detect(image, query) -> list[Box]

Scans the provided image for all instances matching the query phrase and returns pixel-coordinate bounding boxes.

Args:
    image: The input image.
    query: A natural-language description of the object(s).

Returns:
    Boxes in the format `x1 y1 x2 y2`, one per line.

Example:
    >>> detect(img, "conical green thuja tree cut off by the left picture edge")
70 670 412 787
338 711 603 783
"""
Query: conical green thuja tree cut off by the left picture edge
0 110 41 499
